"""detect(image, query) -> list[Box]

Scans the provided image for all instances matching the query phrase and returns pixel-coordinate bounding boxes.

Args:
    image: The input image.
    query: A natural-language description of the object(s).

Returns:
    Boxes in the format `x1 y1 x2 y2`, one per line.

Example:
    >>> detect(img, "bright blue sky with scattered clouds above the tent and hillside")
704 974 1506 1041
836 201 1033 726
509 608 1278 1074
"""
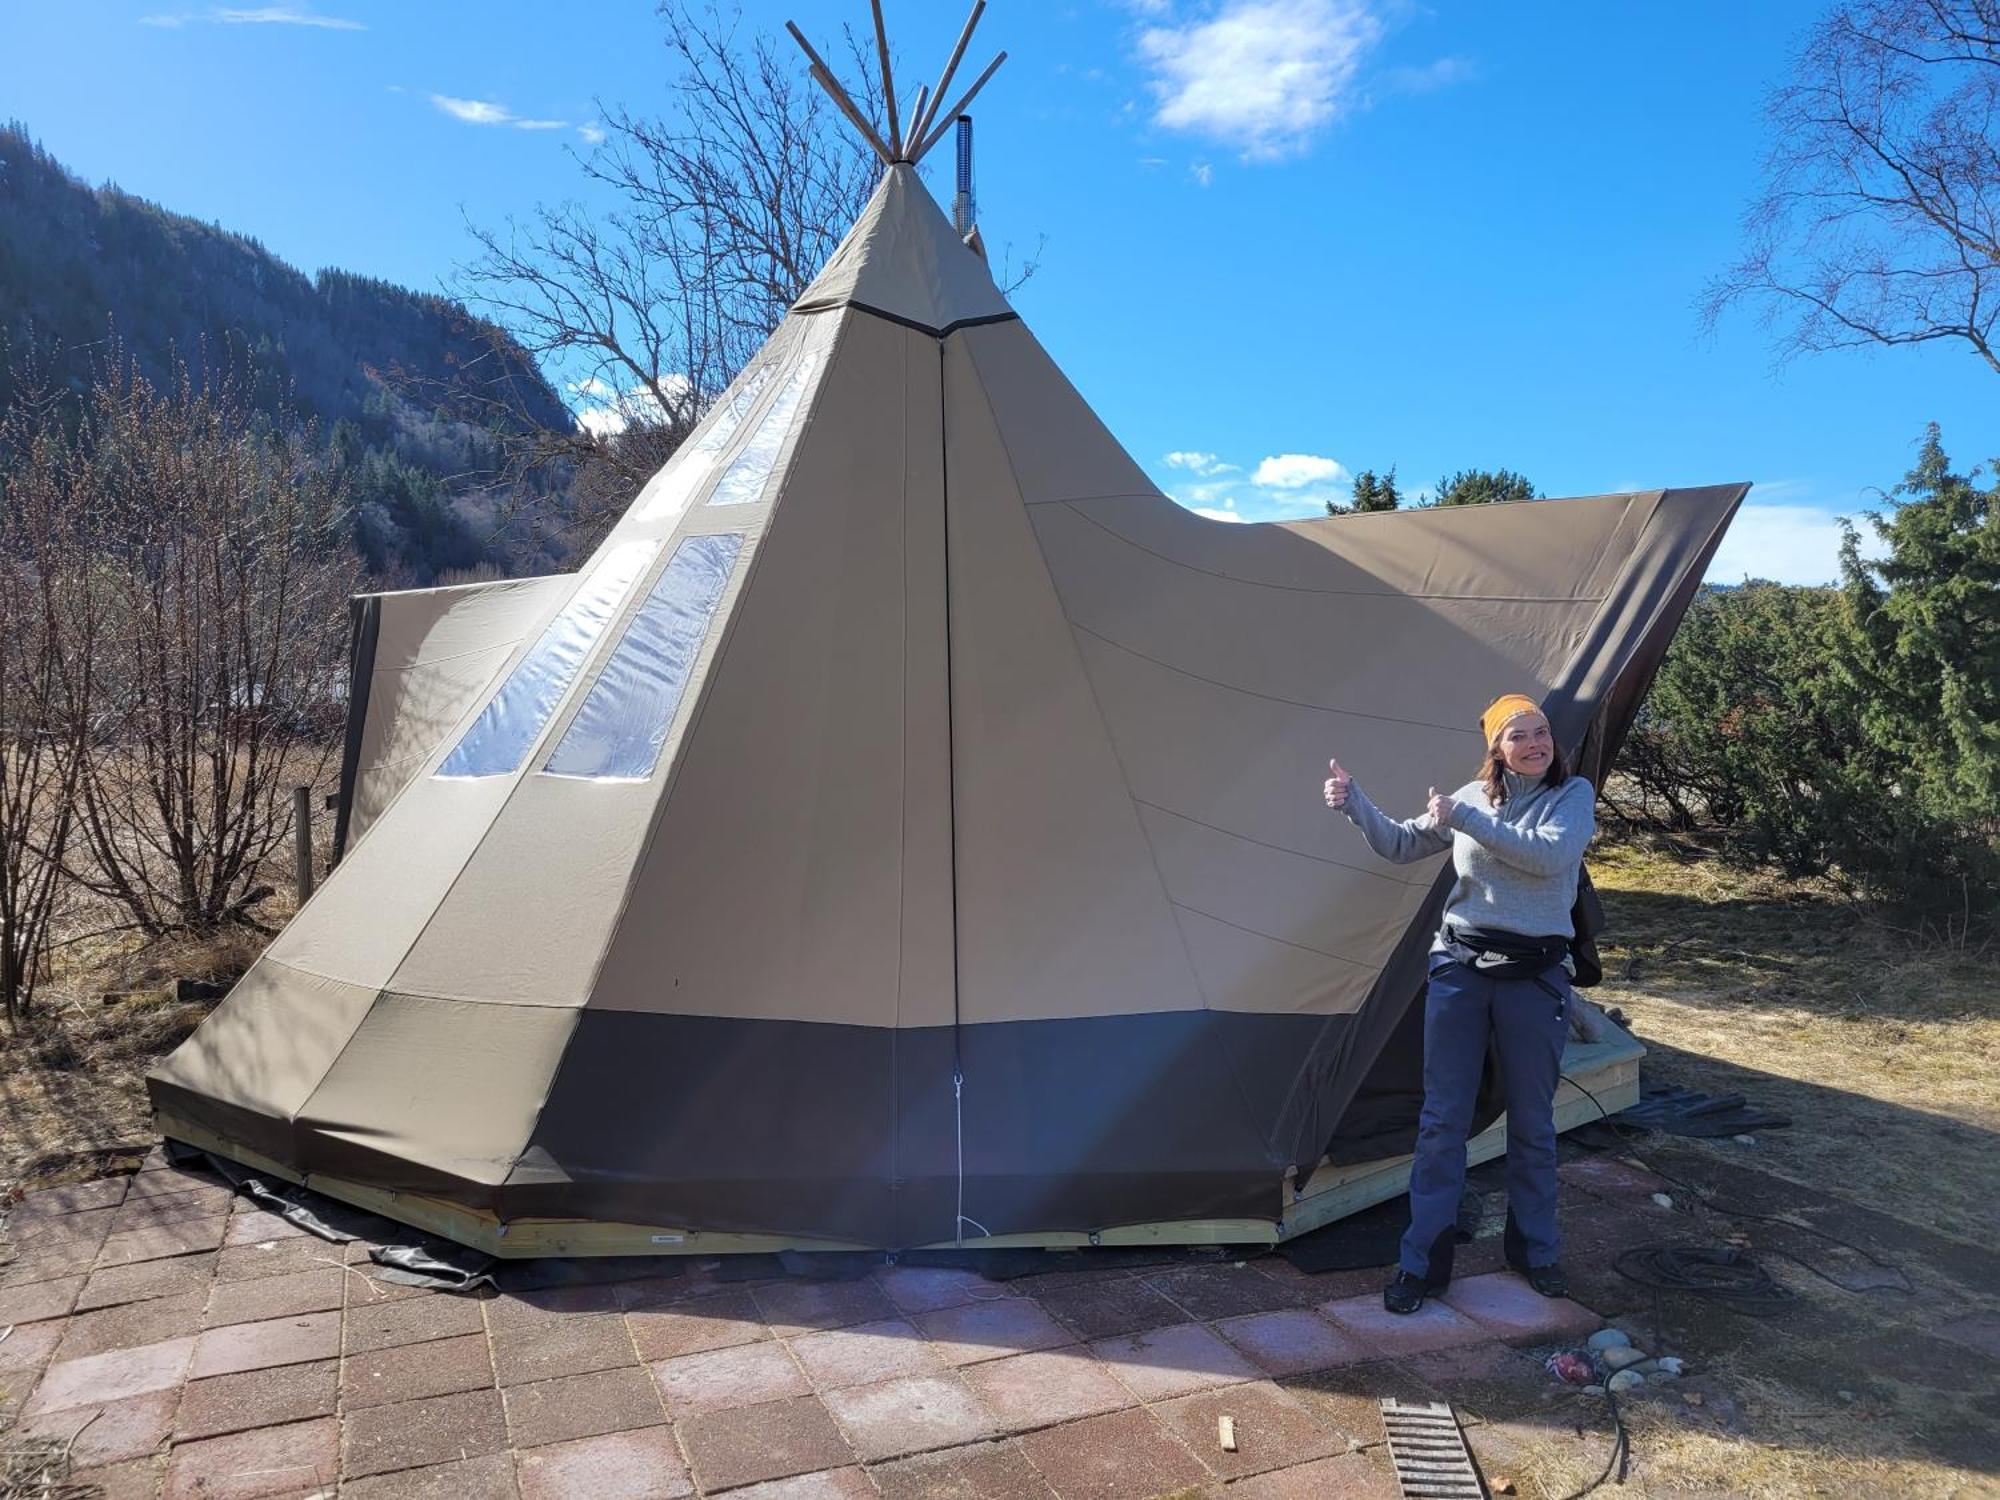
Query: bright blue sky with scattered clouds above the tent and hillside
0 0 2000 582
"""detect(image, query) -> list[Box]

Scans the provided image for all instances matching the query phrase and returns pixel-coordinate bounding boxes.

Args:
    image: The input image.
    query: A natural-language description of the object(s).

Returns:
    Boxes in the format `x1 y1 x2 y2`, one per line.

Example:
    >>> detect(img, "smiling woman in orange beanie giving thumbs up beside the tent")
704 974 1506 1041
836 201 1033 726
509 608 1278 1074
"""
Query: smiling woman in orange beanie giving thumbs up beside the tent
1326 694 1596 1312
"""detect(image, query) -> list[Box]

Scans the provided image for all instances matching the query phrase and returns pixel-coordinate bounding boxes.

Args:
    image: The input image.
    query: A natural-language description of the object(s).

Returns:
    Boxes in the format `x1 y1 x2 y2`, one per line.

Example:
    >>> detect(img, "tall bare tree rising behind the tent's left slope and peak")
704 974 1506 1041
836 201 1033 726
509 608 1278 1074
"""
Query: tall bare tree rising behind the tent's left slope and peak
454 0 880 540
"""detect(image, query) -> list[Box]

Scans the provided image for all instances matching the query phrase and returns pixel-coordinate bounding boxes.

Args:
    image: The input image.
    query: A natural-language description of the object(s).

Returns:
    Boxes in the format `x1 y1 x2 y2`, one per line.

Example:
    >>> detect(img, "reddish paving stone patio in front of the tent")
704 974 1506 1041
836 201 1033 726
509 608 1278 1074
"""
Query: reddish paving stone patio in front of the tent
0 1160 1994 1500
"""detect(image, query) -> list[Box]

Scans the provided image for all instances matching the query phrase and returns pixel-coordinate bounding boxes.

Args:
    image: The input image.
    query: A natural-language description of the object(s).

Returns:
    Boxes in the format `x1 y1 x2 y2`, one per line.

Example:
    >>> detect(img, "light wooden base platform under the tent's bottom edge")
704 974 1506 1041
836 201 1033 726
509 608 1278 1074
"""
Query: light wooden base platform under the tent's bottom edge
154 1026 1646 1260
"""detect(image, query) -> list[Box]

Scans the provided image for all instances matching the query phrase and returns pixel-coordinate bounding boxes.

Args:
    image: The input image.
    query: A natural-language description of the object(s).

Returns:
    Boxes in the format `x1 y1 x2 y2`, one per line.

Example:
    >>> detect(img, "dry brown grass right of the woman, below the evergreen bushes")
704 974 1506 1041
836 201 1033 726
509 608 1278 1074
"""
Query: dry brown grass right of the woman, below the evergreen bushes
1590 844 2000 1244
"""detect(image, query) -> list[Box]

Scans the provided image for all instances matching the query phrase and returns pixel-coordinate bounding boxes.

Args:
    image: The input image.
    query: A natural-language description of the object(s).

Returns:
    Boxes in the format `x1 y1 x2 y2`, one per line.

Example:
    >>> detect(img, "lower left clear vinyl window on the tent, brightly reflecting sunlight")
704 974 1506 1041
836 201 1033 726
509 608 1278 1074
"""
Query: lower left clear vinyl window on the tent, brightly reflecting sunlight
436 542 660 780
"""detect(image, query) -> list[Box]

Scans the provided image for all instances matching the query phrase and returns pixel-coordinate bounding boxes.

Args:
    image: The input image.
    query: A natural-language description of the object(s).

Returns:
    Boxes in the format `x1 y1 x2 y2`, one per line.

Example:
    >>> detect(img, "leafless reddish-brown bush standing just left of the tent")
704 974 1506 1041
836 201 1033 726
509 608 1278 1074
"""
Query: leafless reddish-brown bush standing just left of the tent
80 362 358 936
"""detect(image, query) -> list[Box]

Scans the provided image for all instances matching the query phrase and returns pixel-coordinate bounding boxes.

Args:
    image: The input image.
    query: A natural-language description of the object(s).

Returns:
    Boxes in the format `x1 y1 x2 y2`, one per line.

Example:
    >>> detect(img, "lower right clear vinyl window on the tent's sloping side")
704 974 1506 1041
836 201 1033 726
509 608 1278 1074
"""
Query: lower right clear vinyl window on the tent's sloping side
542 532 744 782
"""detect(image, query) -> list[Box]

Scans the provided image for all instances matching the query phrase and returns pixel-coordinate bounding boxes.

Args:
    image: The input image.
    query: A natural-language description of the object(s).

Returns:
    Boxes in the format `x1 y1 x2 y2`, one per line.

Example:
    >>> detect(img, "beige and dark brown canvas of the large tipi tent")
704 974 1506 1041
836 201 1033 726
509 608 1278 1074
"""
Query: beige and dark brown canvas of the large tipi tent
150 166 1744 1248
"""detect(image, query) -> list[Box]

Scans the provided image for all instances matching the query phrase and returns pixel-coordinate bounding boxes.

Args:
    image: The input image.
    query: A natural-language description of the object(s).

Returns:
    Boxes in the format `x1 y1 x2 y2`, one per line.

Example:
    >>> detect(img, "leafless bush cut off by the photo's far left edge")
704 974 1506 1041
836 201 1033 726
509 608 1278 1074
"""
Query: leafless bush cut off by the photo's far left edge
0 356 100 1026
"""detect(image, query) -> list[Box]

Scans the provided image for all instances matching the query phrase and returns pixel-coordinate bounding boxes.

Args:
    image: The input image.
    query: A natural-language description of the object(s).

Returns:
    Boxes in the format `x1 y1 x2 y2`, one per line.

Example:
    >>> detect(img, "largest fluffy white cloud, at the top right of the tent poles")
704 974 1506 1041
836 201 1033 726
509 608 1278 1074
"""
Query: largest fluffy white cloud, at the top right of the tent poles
1138 0 1382 160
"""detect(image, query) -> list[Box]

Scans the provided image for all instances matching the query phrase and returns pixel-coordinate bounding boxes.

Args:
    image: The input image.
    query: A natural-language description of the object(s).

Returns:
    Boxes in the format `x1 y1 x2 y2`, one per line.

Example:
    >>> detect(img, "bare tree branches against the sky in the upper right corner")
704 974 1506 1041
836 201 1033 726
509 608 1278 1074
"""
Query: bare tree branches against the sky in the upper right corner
1702 0 2000 372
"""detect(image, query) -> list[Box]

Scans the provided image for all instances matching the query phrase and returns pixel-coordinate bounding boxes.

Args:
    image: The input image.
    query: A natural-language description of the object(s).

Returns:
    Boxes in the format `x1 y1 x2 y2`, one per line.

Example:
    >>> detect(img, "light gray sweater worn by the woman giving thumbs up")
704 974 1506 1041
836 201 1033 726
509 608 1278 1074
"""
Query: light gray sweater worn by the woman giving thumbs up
1344 772 1598 952
